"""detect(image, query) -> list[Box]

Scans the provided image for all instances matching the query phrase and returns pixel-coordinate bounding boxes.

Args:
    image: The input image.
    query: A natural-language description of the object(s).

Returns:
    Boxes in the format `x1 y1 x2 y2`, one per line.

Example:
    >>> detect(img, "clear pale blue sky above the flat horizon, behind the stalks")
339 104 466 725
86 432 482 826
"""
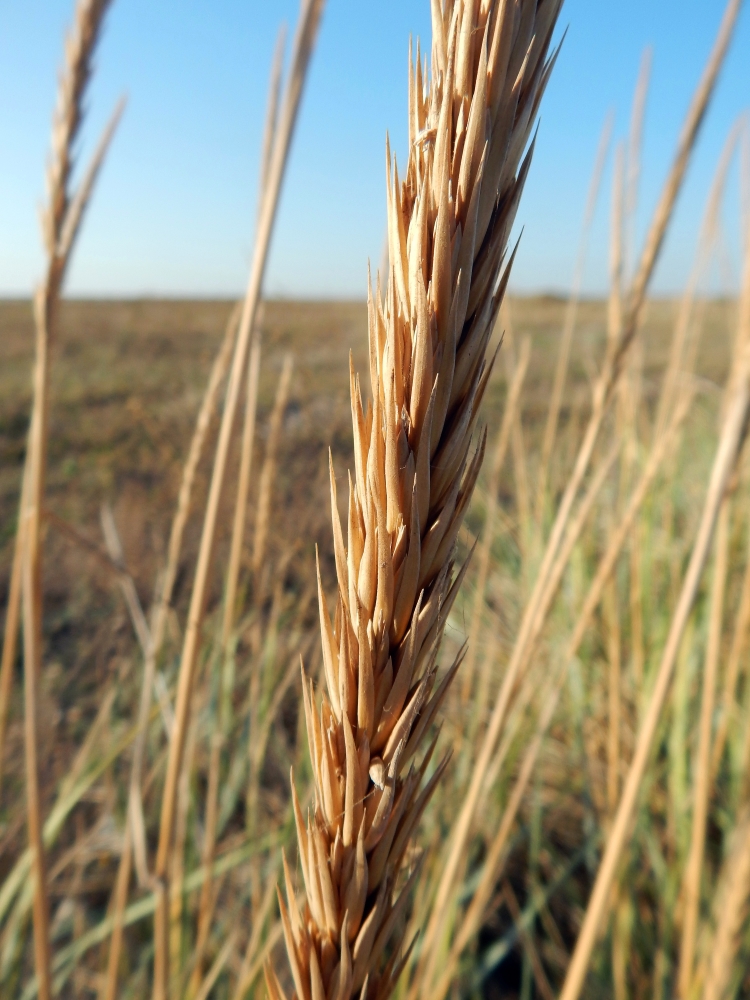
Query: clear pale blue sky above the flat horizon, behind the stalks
0 0 750 297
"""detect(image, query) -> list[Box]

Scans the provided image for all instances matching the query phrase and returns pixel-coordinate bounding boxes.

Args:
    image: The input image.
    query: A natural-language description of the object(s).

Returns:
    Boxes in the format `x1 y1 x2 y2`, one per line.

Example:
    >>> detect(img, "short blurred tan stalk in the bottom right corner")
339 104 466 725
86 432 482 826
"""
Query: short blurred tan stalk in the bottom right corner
701 808 750 1000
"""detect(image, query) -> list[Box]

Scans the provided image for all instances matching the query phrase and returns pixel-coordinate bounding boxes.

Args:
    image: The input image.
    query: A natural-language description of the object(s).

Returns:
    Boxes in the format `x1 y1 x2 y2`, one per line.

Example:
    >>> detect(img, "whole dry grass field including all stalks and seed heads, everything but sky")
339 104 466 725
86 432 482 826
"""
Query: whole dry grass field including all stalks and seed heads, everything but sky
0 0 750 1000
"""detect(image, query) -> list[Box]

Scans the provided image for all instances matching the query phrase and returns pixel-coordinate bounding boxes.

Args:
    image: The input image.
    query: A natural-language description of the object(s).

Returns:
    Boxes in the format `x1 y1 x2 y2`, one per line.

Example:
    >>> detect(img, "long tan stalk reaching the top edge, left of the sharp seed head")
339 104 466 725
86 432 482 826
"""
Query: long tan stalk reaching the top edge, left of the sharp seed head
153 0 324 1000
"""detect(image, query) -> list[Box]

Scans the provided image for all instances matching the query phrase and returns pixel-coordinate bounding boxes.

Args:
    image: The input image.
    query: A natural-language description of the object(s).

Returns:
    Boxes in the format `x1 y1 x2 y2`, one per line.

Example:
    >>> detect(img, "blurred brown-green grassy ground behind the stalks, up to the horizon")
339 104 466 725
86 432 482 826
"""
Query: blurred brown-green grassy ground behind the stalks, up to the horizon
0 298 748 1000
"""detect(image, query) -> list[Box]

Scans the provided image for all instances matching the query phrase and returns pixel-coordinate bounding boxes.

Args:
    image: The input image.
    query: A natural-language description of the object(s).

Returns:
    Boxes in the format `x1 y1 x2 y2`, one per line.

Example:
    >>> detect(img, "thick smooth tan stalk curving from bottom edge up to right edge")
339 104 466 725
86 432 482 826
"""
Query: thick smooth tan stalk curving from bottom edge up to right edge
560 166 750 1000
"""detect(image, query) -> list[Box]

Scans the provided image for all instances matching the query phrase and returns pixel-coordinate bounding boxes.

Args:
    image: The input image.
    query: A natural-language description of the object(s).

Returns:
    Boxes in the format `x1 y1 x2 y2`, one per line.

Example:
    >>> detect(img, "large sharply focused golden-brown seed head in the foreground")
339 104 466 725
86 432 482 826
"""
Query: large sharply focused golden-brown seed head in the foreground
274 0 560 1000
